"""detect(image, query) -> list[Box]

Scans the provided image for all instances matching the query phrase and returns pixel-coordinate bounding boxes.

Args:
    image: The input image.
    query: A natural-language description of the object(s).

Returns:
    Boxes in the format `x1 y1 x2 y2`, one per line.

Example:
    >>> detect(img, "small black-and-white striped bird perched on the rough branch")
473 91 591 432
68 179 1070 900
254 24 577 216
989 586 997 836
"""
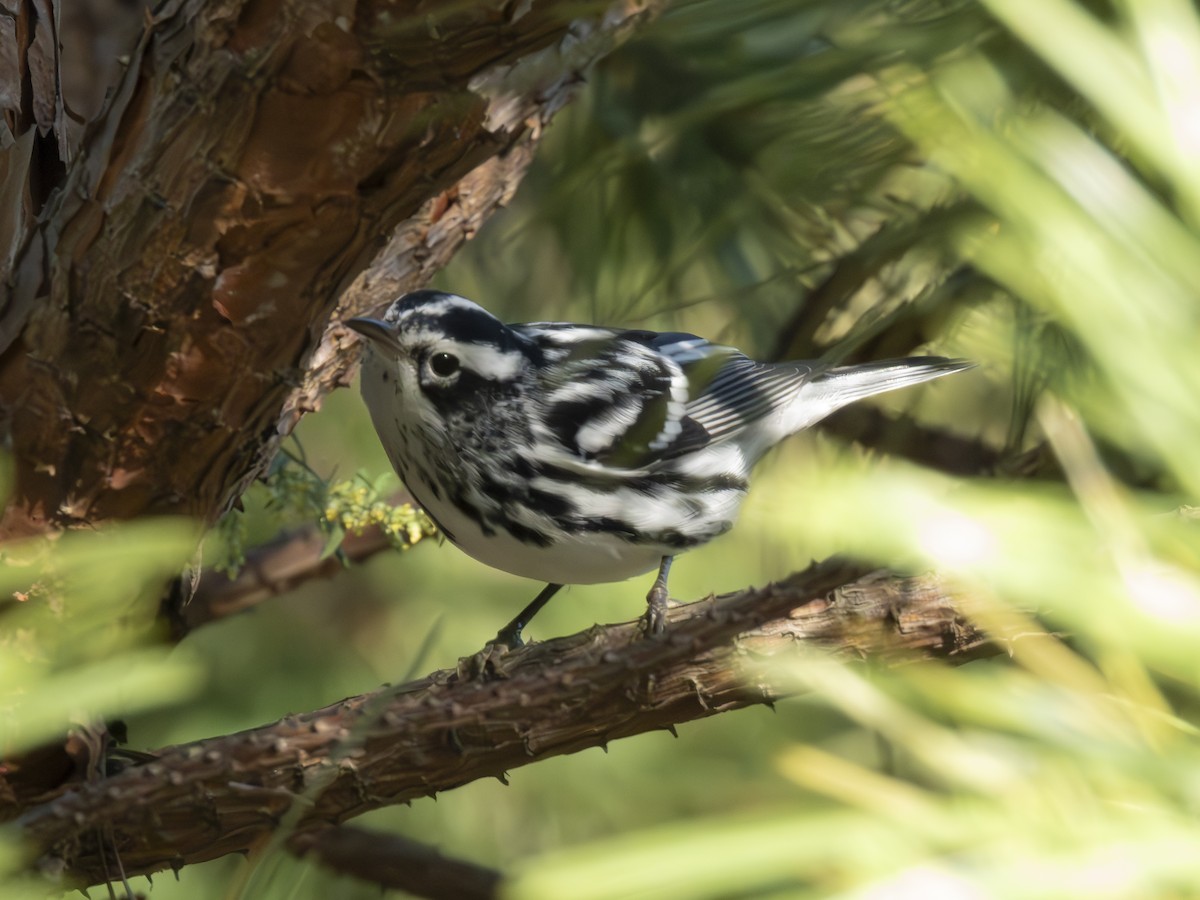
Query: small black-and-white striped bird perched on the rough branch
346 290 971 647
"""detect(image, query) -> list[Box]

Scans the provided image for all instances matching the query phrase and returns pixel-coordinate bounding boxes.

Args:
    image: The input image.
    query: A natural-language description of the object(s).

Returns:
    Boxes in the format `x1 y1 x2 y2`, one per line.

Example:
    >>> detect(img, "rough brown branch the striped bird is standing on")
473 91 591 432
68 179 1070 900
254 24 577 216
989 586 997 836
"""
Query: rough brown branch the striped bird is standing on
13 560 995 883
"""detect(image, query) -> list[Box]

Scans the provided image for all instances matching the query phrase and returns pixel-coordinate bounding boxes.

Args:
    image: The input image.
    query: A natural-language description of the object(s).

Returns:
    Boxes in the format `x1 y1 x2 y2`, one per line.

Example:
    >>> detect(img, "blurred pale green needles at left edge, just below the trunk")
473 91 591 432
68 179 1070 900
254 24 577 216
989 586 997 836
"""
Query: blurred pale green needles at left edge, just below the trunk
0 520 204 896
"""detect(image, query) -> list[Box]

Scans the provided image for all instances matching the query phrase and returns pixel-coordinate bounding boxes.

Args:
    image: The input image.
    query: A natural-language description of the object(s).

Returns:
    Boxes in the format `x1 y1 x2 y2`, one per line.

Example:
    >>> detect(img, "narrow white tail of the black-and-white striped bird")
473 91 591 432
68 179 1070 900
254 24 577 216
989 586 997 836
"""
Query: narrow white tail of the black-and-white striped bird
788 356 974 432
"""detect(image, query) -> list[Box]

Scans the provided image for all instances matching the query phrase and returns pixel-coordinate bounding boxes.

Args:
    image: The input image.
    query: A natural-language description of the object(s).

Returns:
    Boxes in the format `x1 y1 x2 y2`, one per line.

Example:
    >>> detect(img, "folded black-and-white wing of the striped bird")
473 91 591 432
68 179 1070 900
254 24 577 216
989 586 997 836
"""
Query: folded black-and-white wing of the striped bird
520 323 812 469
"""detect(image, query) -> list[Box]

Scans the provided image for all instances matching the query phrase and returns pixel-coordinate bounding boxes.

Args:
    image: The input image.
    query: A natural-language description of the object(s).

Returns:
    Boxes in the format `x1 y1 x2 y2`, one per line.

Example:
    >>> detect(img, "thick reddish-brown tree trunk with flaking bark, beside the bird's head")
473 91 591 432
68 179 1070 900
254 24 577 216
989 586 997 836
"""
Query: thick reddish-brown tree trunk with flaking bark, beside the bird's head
0 0 653 538
